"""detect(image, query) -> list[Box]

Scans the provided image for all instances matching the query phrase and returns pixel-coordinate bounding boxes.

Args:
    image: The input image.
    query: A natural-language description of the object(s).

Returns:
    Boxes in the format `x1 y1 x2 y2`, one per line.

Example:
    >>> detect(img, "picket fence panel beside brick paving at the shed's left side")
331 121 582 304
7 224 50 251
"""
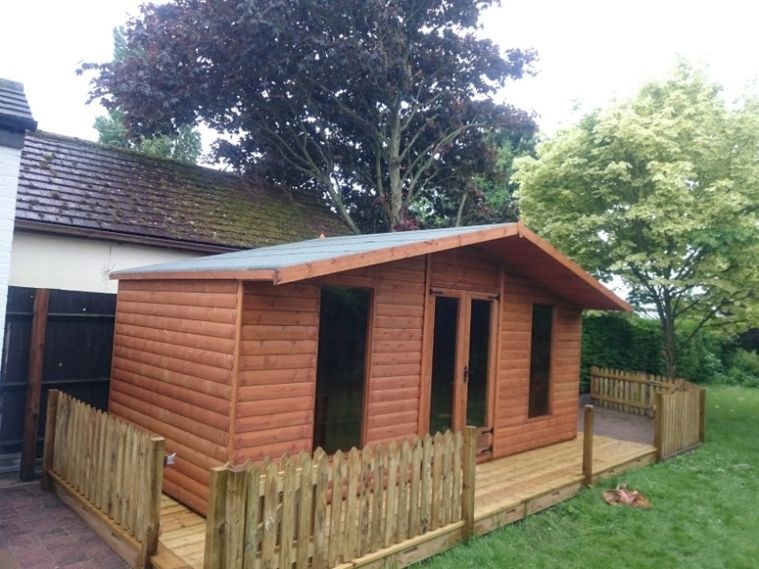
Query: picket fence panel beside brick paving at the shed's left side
42 390 164 568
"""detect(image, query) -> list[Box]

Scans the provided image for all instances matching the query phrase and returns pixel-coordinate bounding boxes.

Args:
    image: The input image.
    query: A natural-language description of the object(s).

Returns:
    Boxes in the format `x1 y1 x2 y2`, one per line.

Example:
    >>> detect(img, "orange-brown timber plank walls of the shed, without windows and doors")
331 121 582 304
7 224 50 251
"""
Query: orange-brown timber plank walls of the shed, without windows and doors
110 247 581 513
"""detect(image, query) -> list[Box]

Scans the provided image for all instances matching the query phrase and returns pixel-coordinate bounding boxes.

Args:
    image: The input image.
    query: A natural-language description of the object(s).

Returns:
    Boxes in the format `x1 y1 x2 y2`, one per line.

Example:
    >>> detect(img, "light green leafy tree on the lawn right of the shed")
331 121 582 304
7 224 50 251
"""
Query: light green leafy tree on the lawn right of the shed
517 64 759 376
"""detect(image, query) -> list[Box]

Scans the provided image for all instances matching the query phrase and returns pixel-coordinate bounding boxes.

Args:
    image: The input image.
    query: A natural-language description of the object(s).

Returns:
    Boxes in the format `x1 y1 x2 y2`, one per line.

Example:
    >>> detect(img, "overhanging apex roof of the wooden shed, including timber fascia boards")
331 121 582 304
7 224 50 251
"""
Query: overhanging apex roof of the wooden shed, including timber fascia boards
111 222 630 310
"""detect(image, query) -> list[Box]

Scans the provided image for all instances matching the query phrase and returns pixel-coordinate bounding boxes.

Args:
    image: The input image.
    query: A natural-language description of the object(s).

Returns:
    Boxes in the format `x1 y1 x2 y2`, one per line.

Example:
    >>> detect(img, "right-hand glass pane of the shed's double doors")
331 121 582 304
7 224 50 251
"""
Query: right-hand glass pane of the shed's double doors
466 299 492 427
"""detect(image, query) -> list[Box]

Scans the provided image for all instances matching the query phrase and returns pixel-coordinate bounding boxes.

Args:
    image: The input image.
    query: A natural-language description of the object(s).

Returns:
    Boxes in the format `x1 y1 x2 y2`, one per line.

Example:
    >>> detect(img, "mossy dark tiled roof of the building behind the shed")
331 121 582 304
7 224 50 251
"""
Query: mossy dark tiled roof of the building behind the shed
16 131 348 249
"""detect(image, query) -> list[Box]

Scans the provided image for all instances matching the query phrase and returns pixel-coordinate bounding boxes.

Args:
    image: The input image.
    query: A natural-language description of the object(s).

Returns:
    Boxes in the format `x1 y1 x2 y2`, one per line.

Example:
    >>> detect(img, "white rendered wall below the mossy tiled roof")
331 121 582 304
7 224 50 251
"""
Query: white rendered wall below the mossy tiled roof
8 231 202 292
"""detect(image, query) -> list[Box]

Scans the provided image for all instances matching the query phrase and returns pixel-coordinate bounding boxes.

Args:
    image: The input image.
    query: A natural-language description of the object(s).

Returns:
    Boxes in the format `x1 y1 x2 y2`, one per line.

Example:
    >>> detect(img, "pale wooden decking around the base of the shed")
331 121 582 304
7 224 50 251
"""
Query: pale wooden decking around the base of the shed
153 436 656 569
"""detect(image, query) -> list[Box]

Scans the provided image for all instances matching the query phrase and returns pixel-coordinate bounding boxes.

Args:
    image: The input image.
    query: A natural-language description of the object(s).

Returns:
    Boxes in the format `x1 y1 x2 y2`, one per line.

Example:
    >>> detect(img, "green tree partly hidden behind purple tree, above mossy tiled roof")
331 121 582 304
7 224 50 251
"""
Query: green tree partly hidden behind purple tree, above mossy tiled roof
93 27 203 164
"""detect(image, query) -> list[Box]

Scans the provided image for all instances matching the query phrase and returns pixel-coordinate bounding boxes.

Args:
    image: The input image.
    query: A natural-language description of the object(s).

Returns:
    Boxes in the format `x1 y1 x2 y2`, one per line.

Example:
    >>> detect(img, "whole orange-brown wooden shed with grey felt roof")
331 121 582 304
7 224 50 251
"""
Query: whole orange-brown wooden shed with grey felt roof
110 223 629 512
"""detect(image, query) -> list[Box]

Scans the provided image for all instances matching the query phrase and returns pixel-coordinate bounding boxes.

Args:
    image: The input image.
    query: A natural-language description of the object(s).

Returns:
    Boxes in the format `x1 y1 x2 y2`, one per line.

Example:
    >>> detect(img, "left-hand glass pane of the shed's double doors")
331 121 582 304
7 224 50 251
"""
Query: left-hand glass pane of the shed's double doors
430 296 459 433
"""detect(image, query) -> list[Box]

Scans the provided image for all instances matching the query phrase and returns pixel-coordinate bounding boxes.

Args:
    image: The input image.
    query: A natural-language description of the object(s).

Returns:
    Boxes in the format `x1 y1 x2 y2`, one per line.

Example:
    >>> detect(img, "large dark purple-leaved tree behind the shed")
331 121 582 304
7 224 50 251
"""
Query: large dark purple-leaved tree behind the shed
85 0 533 232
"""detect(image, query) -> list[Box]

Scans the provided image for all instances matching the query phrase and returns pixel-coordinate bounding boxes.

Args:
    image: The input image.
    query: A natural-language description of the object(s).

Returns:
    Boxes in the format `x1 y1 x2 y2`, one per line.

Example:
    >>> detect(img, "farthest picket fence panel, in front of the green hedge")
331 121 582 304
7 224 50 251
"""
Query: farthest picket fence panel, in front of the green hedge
590 366 685 417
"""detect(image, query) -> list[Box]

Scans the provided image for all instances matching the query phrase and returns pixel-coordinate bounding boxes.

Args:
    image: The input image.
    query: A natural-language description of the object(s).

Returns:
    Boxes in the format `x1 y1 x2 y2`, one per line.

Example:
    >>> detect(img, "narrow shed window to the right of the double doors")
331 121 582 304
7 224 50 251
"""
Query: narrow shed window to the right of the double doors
527 304 553 417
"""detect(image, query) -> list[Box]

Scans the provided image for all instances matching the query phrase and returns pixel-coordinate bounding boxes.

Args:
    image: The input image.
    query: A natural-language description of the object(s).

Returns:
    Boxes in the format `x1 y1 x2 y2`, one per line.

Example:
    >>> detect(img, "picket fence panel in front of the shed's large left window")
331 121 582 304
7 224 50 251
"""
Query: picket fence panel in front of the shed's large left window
204 428 476 569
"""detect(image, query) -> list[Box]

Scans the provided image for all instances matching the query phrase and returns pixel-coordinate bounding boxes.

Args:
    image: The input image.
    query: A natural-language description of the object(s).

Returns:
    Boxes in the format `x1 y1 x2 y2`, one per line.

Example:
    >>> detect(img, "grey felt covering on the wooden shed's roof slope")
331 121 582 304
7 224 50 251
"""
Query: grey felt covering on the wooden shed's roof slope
111 223 504 278
